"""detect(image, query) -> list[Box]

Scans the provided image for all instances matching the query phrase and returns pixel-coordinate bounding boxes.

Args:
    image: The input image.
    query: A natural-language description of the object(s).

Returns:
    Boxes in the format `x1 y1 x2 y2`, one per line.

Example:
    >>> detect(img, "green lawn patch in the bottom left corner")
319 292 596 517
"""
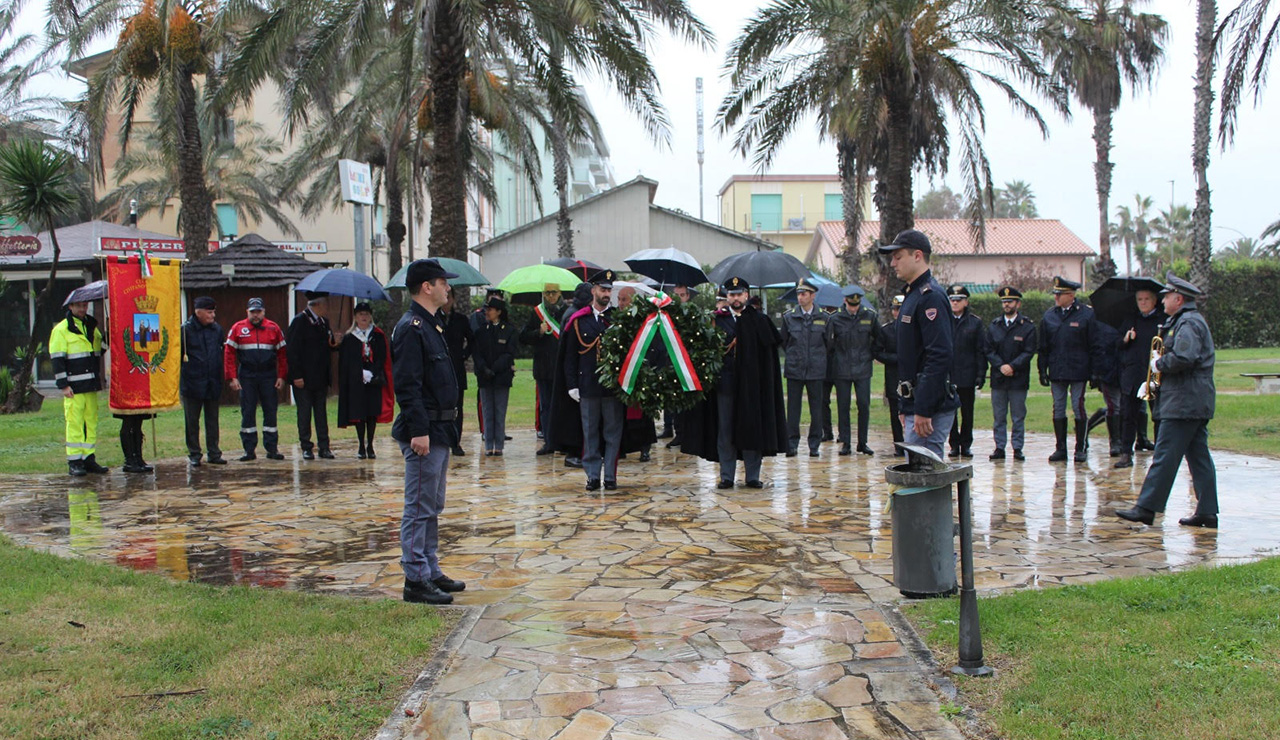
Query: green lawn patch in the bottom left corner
0 538 451 740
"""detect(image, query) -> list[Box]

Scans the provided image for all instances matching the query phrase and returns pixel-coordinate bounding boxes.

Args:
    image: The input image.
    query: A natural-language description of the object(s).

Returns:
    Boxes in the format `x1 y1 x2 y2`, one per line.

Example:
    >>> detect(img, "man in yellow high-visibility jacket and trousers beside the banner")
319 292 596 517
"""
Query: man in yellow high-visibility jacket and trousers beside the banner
49 301 106 476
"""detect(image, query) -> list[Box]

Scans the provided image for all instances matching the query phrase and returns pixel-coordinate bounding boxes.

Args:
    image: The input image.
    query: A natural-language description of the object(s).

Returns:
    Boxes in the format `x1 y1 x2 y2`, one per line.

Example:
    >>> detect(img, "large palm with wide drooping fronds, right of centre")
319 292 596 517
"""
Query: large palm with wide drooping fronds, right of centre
717 0 1065 286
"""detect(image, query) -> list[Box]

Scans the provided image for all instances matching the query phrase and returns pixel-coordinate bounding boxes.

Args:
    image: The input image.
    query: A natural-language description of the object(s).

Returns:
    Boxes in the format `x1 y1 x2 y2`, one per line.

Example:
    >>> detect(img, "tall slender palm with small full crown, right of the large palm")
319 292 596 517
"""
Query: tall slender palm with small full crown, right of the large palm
1044 0 1169 279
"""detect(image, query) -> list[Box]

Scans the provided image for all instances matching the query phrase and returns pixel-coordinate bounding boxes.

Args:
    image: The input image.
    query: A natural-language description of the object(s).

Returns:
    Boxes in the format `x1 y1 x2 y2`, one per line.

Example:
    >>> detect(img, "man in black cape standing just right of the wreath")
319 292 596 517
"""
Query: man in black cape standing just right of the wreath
680 277 787 489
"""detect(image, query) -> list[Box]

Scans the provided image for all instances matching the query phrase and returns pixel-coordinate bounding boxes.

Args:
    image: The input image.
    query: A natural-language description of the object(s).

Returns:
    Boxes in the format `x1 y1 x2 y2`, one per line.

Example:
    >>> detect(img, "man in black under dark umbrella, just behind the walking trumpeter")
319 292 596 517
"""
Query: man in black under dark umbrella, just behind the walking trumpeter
1112 291 1166 467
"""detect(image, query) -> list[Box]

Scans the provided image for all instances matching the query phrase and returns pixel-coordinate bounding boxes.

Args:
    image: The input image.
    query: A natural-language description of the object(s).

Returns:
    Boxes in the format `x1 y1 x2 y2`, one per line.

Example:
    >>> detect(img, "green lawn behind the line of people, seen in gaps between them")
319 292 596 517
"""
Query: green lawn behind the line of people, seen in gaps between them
12 348 1280 472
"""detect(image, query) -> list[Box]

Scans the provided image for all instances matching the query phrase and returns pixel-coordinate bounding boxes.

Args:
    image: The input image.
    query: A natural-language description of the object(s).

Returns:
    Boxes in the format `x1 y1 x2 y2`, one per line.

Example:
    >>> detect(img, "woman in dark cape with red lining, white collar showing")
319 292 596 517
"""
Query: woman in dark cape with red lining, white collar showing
338 303 396 460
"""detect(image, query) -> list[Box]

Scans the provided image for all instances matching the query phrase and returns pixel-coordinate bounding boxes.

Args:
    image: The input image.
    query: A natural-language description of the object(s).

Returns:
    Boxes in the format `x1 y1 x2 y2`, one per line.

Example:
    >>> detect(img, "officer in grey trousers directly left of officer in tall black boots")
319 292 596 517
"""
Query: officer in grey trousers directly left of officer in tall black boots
987 286 1036 461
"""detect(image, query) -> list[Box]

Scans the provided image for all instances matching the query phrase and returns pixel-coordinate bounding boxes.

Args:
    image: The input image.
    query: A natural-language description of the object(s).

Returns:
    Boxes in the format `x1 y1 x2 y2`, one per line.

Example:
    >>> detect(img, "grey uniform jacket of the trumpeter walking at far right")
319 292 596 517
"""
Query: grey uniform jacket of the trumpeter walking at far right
1156 301 1217 419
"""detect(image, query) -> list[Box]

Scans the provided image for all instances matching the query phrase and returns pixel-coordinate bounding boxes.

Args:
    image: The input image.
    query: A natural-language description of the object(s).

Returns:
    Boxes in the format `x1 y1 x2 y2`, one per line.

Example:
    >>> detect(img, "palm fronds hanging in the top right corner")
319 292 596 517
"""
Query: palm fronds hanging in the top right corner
1217 0 1280 146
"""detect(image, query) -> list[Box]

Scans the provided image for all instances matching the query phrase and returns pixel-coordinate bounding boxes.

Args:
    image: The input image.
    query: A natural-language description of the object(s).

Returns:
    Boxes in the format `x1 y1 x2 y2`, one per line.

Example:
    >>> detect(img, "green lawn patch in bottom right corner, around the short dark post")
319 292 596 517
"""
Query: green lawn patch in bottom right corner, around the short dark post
904 558 1280 740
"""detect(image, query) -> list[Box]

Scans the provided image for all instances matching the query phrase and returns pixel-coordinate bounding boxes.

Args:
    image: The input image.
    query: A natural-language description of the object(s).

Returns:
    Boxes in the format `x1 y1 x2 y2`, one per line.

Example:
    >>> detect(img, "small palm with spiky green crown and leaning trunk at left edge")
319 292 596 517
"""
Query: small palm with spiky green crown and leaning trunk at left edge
0 140 77 414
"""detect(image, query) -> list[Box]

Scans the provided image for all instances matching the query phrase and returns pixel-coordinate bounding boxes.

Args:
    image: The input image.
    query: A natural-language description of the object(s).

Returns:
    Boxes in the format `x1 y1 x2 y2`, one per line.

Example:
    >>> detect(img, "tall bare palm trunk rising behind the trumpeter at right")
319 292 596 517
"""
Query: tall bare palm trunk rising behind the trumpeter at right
1190 0 1217 293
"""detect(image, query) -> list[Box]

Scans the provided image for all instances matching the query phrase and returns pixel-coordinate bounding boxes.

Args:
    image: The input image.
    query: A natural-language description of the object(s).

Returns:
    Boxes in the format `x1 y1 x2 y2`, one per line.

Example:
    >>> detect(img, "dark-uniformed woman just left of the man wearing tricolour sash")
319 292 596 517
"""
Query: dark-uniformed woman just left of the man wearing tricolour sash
471 296 520 457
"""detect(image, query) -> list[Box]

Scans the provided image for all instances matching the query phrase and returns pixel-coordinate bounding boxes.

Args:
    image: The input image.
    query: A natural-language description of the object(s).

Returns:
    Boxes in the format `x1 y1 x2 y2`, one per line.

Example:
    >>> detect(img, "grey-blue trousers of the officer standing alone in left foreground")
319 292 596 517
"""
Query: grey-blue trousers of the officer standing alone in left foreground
397 440 449 581
